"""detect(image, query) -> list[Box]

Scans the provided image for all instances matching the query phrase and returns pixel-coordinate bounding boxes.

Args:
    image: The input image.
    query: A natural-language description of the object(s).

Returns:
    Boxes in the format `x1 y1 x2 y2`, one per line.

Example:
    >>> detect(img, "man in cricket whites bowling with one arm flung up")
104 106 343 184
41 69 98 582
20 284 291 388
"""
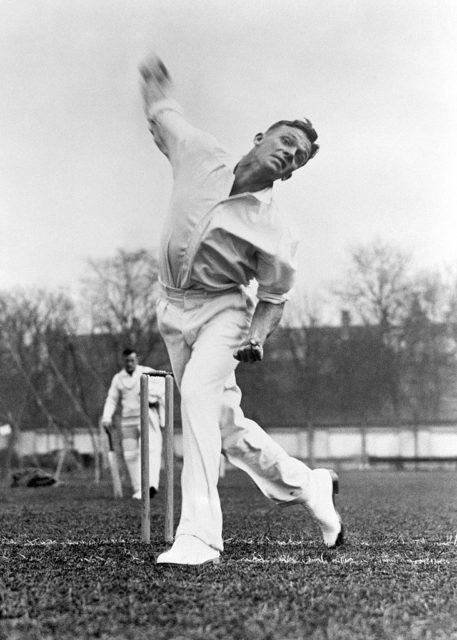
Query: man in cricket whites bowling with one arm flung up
140 55 343 565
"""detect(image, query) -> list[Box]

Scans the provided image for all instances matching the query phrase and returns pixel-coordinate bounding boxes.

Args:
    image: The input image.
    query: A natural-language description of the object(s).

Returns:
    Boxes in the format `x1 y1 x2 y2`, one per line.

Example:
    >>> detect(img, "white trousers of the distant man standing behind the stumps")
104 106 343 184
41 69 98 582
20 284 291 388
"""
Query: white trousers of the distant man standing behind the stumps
122 409 162 493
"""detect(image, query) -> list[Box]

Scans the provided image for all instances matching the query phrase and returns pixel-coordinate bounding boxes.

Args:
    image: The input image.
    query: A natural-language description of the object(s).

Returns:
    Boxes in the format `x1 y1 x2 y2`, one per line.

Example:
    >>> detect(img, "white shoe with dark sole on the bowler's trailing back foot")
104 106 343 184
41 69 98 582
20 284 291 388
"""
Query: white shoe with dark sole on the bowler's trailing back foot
304 469 344 549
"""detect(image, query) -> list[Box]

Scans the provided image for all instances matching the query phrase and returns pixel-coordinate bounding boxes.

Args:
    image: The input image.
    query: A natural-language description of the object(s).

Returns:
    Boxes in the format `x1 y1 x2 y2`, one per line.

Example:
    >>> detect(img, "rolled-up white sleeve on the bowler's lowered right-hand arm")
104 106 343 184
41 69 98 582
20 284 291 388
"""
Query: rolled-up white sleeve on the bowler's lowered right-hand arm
256 229 298 304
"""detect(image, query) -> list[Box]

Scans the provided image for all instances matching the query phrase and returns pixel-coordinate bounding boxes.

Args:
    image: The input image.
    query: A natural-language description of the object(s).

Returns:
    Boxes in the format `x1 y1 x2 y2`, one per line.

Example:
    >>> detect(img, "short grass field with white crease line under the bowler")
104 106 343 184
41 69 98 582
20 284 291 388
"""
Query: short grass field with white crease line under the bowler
0 464 457 640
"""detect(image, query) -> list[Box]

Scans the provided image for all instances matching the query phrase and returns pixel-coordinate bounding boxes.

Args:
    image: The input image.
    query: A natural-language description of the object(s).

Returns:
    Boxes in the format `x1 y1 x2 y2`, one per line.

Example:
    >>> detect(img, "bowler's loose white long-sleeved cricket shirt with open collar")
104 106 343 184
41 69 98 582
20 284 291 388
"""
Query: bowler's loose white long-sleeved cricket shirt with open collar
147 99 298 304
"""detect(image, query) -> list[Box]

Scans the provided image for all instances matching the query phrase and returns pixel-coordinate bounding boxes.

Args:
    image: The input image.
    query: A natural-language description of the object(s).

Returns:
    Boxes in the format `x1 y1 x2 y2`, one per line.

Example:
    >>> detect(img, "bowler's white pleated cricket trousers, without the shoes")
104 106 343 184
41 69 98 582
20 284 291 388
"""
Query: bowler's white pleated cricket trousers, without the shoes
157 287 311 551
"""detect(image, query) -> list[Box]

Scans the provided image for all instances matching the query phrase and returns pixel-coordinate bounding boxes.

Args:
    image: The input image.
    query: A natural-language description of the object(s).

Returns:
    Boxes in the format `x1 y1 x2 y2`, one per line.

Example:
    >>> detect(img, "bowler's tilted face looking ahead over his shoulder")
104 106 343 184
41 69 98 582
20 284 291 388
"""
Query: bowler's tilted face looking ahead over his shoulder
254 124 312 181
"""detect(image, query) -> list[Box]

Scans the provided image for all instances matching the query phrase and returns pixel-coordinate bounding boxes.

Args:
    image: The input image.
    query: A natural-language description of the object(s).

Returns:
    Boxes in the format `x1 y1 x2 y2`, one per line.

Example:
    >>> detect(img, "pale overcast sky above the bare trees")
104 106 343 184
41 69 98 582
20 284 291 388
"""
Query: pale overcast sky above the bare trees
0 0 457 298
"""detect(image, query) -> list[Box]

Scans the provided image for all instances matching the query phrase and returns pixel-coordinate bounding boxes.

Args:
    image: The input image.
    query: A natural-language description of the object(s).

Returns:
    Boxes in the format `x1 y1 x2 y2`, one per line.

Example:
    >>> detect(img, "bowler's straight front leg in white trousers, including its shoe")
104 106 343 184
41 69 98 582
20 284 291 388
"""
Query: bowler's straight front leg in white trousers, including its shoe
157 293 248 564
